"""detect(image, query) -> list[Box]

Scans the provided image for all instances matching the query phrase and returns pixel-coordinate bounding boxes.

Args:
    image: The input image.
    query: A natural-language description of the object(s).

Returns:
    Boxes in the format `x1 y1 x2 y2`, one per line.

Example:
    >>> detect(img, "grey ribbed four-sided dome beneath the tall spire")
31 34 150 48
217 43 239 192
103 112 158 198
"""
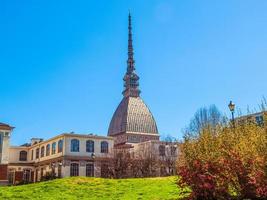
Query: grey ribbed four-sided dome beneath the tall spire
108 96 158 136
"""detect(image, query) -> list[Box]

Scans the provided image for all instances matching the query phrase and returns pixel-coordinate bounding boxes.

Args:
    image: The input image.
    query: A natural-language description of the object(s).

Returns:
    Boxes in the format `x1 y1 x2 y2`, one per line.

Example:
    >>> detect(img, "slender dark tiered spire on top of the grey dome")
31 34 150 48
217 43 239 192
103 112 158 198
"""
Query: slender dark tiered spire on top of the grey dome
122 13 141 97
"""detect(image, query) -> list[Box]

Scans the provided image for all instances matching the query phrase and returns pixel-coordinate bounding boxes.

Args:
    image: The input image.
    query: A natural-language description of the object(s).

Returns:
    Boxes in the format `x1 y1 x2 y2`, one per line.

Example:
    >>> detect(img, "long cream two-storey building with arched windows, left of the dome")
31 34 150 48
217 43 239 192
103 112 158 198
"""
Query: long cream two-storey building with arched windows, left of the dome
0 132 113 184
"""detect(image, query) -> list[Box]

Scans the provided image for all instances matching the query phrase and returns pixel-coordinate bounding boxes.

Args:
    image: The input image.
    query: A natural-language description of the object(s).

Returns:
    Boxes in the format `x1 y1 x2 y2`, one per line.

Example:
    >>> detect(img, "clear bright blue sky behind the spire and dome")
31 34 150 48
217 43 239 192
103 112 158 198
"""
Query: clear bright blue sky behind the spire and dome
0 0 267 144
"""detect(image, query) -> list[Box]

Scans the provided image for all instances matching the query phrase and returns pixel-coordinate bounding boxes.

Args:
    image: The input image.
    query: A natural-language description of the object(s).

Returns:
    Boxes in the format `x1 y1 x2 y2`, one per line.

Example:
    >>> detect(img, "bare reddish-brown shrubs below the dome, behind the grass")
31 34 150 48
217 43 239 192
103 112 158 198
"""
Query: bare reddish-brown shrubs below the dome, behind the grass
112 141 179 178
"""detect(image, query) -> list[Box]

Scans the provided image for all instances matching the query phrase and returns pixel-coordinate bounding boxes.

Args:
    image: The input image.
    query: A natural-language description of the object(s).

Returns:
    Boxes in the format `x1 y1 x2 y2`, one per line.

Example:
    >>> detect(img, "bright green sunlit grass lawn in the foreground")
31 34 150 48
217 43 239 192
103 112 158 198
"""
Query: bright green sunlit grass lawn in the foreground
0 177 191 200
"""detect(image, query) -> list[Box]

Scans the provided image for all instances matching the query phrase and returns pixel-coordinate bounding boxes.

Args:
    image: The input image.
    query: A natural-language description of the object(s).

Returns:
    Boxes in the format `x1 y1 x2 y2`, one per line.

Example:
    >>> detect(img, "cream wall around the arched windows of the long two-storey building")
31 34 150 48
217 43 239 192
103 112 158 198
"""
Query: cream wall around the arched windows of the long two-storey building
5 134 114 184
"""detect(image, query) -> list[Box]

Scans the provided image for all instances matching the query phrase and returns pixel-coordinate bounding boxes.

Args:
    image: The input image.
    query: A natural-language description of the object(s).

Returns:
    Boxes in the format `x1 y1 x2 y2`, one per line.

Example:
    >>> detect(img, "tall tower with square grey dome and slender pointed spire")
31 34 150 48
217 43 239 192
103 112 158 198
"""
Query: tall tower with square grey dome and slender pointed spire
108 14 159 145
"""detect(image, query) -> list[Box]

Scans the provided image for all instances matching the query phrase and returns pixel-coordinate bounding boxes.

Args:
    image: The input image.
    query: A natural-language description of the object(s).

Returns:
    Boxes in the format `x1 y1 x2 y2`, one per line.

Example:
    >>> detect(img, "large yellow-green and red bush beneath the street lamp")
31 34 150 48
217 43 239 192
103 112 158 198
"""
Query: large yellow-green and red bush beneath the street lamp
177 108 267 199
